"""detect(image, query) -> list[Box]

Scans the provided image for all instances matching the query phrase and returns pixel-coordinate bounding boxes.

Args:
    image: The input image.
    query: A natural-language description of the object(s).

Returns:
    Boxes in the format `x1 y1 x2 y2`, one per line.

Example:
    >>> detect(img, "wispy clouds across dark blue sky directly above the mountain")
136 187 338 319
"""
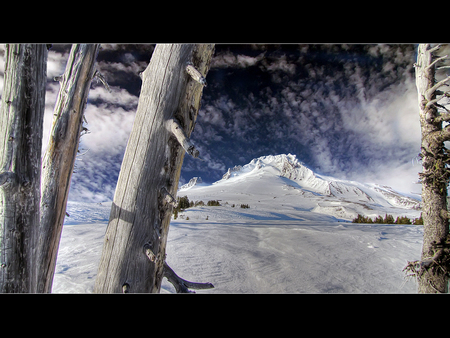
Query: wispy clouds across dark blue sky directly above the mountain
188 45 420 195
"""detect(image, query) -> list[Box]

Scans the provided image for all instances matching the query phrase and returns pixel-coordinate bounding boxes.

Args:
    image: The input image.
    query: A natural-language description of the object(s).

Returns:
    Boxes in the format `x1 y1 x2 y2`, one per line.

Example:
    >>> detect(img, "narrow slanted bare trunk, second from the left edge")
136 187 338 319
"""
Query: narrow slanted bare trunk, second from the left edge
37 44 100 293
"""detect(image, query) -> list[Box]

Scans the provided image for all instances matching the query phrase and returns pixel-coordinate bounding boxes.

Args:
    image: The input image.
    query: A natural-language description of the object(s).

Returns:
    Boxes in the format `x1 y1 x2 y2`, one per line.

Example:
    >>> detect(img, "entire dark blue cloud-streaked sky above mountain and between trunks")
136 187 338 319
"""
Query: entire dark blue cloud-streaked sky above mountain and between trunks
0 44 421 202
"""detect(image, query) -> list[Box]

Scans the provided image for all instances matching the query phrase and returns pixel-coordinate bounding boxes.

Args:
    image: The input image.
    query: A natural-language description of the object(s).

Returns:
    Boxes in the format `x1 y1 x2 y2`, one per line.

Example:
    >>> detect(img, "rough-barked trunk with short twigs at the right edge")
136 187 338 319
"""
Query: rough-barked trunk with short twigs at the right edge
415 44 450 293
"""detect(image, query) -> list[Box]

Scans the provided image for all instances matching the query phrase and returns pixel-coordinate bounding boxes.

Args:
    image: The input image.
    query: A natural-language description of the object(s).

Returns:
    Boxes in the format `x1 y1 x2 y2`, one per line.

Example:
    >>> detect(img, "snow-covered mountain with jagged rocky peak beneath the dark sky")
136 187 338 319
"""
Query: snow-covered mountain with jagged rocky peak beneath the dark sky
178 154 420 220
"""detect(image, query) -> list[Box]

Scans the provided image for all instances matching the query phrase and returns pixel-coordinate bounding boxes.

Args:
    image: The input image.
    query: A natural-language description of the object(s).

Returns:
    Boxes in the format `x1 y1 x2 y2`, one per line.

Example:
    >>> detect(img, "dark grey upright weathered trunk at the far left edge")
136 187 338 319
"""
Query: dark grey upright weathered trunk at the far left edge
0 44 47 292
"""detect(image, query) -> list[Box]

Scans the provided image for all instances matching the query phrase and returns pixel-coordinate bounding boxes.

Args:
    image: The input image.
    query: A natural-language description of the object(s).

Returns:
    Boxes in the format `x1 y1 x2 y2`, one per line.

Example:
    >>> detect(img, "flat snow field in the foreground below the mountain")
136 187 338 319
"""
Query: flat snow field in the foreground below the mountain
53 207 423 293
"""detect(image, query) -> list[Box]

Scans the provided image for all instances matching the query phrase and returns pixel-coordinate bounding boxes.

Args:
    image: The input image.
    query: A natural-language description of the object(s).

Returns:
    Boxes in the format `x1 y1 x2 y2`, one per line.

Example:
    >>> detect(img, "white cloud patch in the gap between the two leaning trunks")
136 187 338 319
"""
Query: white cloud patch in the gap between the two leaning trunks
70 86 138 202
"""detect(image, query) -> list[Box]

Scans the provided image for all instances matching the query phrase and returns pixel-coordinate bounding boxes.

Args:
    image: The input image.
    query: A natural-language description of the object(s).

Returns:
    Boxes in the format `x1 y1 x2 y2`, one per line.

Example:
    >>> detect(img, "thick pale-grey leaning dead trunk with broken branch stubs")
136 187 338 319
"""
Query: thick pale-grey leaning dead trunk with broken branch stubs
95 45 214 293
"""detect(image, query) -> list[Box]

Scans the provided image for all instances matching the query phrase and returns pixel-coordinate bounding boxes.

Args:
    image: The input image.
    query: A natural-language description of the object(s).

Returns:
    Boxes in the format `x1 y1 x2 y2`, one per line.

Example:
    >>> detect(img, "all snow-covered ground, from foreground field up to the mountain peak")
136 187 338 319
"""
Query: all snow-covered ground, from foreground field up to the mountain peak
53 155 423 293
